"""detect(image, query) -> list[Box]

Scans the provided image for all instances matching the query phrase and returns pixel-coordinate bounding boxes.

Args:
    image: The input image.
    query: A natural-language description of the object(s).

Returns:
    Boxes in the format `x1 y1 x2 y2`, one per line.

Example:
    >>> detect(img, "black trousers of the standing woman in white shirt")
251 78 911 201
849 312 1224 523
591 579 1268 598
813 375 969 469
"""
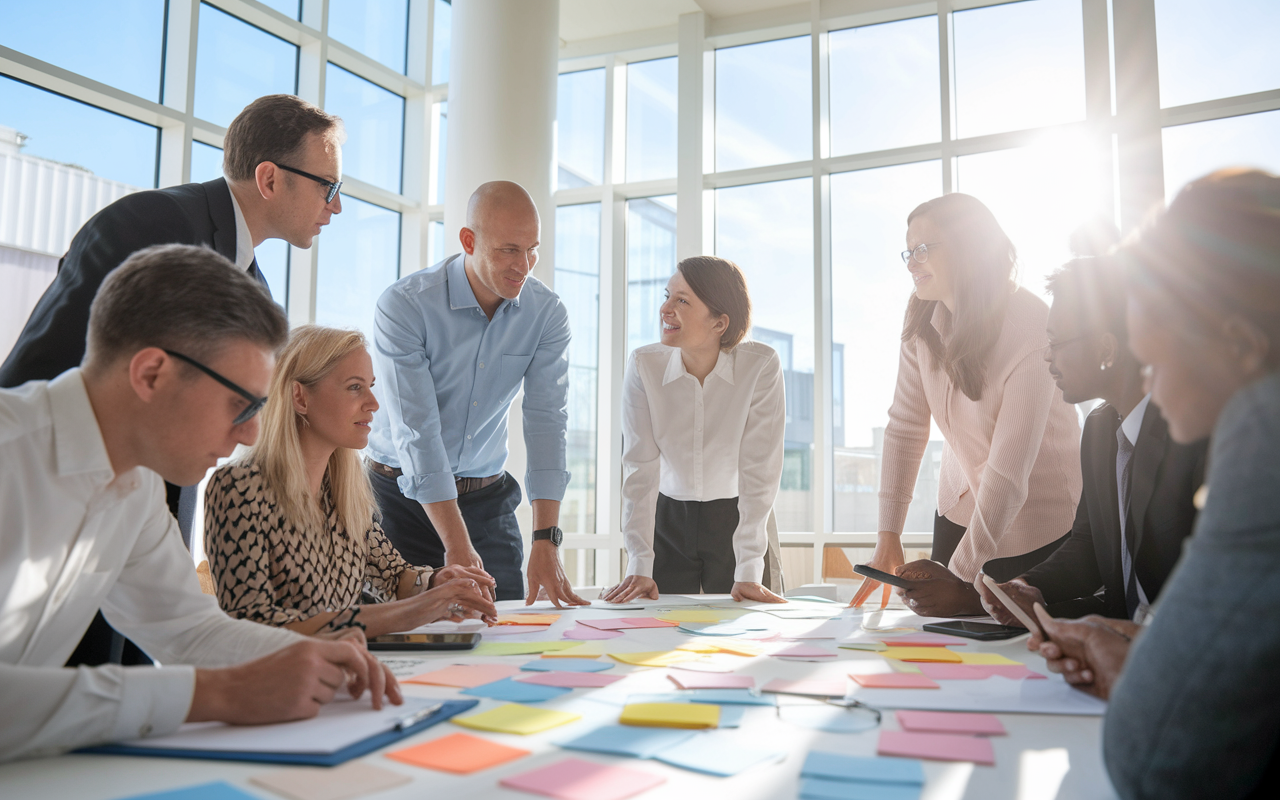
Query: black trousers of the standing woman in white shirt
653 494 737 594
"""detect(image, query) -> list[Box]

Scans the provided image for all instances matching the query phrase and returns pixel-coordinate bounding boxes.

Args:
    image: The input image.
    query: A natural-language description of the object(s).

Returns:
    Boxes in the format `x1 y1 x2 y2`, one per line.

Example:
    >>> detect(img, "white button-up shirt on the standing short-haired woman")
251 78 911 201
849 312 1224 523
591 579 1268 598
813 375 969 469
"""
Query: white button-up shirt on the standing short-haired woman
622 342 786 582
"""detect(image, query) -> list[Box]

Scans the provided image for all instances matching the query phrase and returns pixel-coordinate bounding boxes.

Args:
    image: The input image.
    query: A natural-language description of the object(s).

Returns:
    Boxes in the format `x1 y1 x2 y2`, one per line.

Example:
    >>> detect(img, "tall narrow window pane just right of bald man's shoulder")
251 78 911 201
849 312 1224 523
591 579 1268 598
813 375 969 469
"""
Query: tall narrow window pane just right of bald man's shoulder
556 202 600 534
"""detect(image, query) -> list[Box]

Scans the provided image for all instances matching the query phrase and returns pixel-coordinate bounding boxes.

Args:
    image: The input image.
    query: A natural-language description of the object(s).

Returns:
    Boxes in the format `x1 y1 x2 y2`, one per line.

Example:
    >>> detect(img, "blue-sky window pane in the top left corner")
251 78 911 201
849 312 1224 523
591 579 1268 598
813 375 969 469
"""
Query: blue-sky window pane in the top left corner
0 0 165 101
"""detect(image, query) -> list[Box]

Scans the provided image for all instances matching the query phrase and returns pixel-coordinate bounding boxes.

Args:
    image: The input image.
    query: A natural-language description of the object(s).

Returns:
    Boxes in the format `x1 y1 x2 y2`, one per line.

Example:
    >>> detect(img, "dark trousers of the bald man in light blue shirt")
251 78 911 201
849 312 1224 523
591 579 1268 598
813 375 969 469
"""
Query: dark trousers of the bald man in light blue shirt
366 470 525 600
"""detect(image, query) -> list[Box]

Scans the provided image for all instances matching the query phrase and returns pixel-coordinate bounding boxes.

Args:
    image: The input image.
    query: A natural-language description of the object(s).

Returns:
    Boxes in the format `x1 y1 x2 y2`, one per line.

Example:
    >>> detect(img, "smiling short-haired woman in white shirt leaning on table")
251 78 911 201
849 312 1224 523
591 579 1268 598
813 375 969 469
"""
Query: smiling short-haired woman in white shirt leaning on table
602 256 786 603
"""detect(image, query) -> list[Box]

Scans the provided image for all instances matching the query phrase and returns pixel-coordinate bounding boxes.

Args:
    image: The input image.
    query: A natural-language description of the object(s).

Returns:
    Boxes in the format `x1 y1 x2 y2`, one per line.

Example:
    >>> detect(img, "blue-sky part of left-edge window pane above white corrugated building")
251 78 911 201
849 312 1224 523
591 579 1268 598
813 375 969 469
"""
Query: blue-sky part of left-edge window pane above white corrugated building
0 76 160 189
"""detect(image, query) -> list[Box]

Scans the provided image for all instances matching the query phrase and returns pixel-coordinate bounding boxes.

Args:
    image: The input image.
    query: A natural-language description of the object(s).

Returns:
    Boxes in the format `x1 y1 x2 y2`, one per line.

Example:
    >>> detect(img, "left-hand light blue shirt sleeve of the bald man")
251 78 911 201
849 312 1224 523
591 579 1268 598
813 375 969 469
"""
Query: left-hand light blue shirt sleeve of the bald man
374 285 458 503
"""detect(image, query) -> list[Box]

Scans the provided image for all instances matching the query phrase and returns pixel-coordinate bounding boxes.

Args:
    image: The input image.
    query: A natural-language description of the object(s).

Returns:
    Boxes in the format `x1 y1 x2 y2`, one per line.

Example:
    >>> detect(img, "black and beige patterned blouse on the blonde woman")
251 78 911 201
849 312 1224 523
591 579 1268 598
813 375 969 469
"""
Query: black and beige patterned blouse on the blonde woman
205 465 430 626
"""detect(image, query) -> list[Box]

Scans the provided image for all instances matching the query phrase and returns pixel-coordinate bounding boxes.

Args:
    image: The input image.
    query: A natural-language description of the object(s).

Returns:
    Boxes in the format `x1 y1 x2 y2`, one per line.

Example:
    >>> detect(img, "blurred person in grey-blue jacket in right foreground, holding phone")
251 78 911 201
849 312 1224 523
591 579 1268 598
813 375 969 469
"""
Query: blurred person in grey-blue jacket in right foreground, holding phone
1028 170 1280 800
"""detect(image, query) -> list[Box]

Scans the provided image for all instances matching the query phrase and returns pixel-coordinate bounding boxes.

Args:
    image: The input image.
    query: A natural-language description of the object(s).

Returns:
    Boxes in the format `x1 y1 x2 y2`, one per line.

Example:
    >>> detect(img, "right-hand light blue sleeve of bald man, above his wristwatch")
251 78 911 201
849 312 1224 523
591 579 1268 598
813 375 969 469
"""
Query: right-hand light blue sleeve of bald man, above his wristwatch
522 300 570 502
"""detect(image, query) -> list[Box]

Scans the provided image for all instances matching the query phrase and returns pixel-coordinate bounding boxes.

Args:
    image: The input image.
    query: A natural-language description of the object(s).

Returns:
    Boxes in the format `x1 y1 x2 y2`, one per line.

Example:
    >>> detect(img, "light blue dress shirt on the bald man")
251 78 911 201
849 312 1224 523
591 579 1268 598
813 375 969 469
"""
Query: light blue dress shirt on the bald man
366 253 570 503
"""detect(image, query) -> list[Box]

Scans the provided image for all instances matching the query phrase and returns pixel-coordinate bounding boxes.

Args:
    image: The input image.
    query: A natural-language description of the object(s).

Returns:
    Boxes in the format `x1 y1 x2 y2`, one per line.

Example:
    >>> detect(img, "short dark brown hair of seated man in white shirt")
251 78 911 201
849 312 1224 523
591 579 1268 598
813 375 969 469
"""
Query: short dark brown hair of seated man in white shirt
82 244 289 371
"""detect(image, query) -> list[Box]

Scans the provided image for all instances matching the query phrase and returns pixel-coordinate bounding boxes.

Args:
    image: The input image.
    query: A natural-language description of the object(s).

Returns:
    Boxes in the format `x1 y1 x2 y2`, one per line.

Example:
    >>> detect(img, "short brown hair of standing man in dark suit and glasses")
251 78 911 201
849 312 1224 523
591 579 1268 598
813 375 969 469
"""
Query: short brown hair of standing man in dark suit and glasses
223 95 346 180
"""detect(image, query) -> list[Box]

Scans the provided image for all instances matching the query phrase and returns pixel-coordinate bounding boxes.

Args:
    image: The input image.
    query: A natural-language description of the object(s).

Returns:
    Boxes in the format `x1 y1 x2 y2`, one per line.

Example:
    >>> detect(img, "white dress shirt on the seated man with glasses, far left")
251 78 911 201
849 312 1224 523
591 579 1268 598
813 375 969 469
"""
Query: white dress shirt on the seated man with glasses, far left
0 369 300 762
